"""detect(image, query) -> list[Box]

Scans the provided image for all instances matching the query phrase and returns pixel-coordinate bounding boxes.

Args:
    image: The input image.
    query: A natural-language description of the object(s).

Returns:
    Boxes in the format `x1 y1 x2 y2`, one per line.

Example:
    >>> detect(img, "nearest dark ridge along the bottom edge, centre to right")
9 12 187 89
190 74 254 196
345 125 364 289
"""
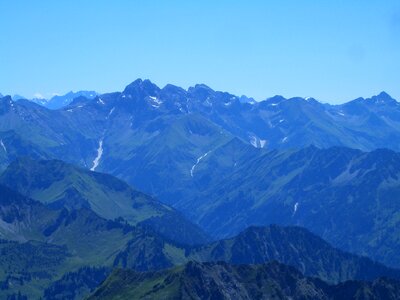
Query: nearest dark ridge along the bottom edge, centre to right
89 262 400 300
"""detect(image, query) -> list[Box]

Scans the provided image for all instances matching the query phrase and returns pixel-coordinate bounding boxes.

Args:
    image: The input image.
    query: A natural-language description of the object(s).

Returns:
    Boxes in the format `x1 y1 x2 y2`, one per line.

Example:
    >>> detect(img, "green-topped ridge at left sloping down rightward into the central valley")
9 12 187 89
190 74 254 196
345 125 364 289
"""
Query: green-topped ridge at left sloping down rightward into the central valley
0 158 209 245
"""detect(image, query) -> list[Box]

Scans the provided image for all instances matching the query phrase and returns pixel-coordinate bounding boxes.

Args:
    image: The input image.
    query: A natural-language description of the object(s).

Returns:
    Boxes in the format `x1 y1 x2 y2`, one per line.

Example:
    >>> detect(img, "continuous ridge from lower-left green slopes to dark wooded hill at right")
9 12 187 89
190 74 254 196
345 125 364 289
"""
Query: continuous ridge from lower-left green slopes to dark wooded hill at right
0 179 400 297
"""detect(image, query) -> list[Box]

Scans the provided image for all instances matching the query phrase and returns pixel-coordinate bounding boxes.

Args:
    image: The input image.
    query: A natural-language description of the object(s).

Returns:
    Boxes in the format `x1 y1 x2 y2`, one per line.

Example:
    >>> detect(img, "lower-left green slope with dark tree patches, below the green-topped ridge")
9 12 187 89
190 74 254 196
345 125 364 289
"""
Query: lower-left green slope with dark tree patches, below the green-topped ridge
0 185 198 298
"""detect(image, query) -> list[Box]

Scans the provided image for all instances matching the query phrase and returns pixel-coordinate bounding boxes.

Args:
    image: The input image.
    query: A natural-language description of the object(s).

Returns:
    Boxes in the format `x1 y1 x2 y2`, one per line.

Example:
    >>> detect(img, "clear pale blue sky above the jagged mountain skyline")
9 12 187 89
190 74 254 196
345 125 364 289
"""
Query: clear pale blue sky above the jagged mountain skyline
0 0 400 103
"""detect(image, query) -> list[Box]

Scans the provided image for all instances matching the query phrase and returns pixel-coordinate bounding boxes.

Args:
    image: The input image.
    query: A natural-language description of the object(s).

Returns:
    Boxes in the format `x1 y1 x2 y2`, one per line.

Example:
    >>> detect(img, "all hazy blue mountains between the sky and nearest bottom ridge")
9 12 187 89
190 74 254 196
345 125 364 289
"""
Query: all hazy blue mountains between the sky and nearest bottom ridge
0 79 400 299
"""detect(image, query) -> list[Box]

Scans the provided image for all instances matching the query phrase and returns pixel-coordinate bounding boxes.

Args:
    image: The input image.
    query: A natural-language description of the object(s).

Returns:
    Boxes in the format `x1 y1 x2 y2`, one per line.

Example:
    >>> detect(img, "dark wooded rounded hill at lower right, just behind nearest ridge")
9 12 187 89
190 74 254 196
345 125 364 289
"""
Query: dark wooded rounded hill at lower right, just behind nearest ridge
187 225 400 283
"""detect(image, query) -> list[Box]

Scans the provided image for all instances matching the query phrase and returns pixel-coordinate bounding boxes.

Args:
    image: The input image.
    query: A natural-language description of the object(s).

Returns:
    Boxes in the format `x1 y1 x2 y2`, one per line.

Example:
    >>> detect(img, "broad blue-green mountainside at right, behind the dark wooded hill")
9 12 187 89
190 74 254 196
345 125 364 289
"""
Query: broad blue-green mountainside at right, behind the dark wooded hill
173 141 400 266
